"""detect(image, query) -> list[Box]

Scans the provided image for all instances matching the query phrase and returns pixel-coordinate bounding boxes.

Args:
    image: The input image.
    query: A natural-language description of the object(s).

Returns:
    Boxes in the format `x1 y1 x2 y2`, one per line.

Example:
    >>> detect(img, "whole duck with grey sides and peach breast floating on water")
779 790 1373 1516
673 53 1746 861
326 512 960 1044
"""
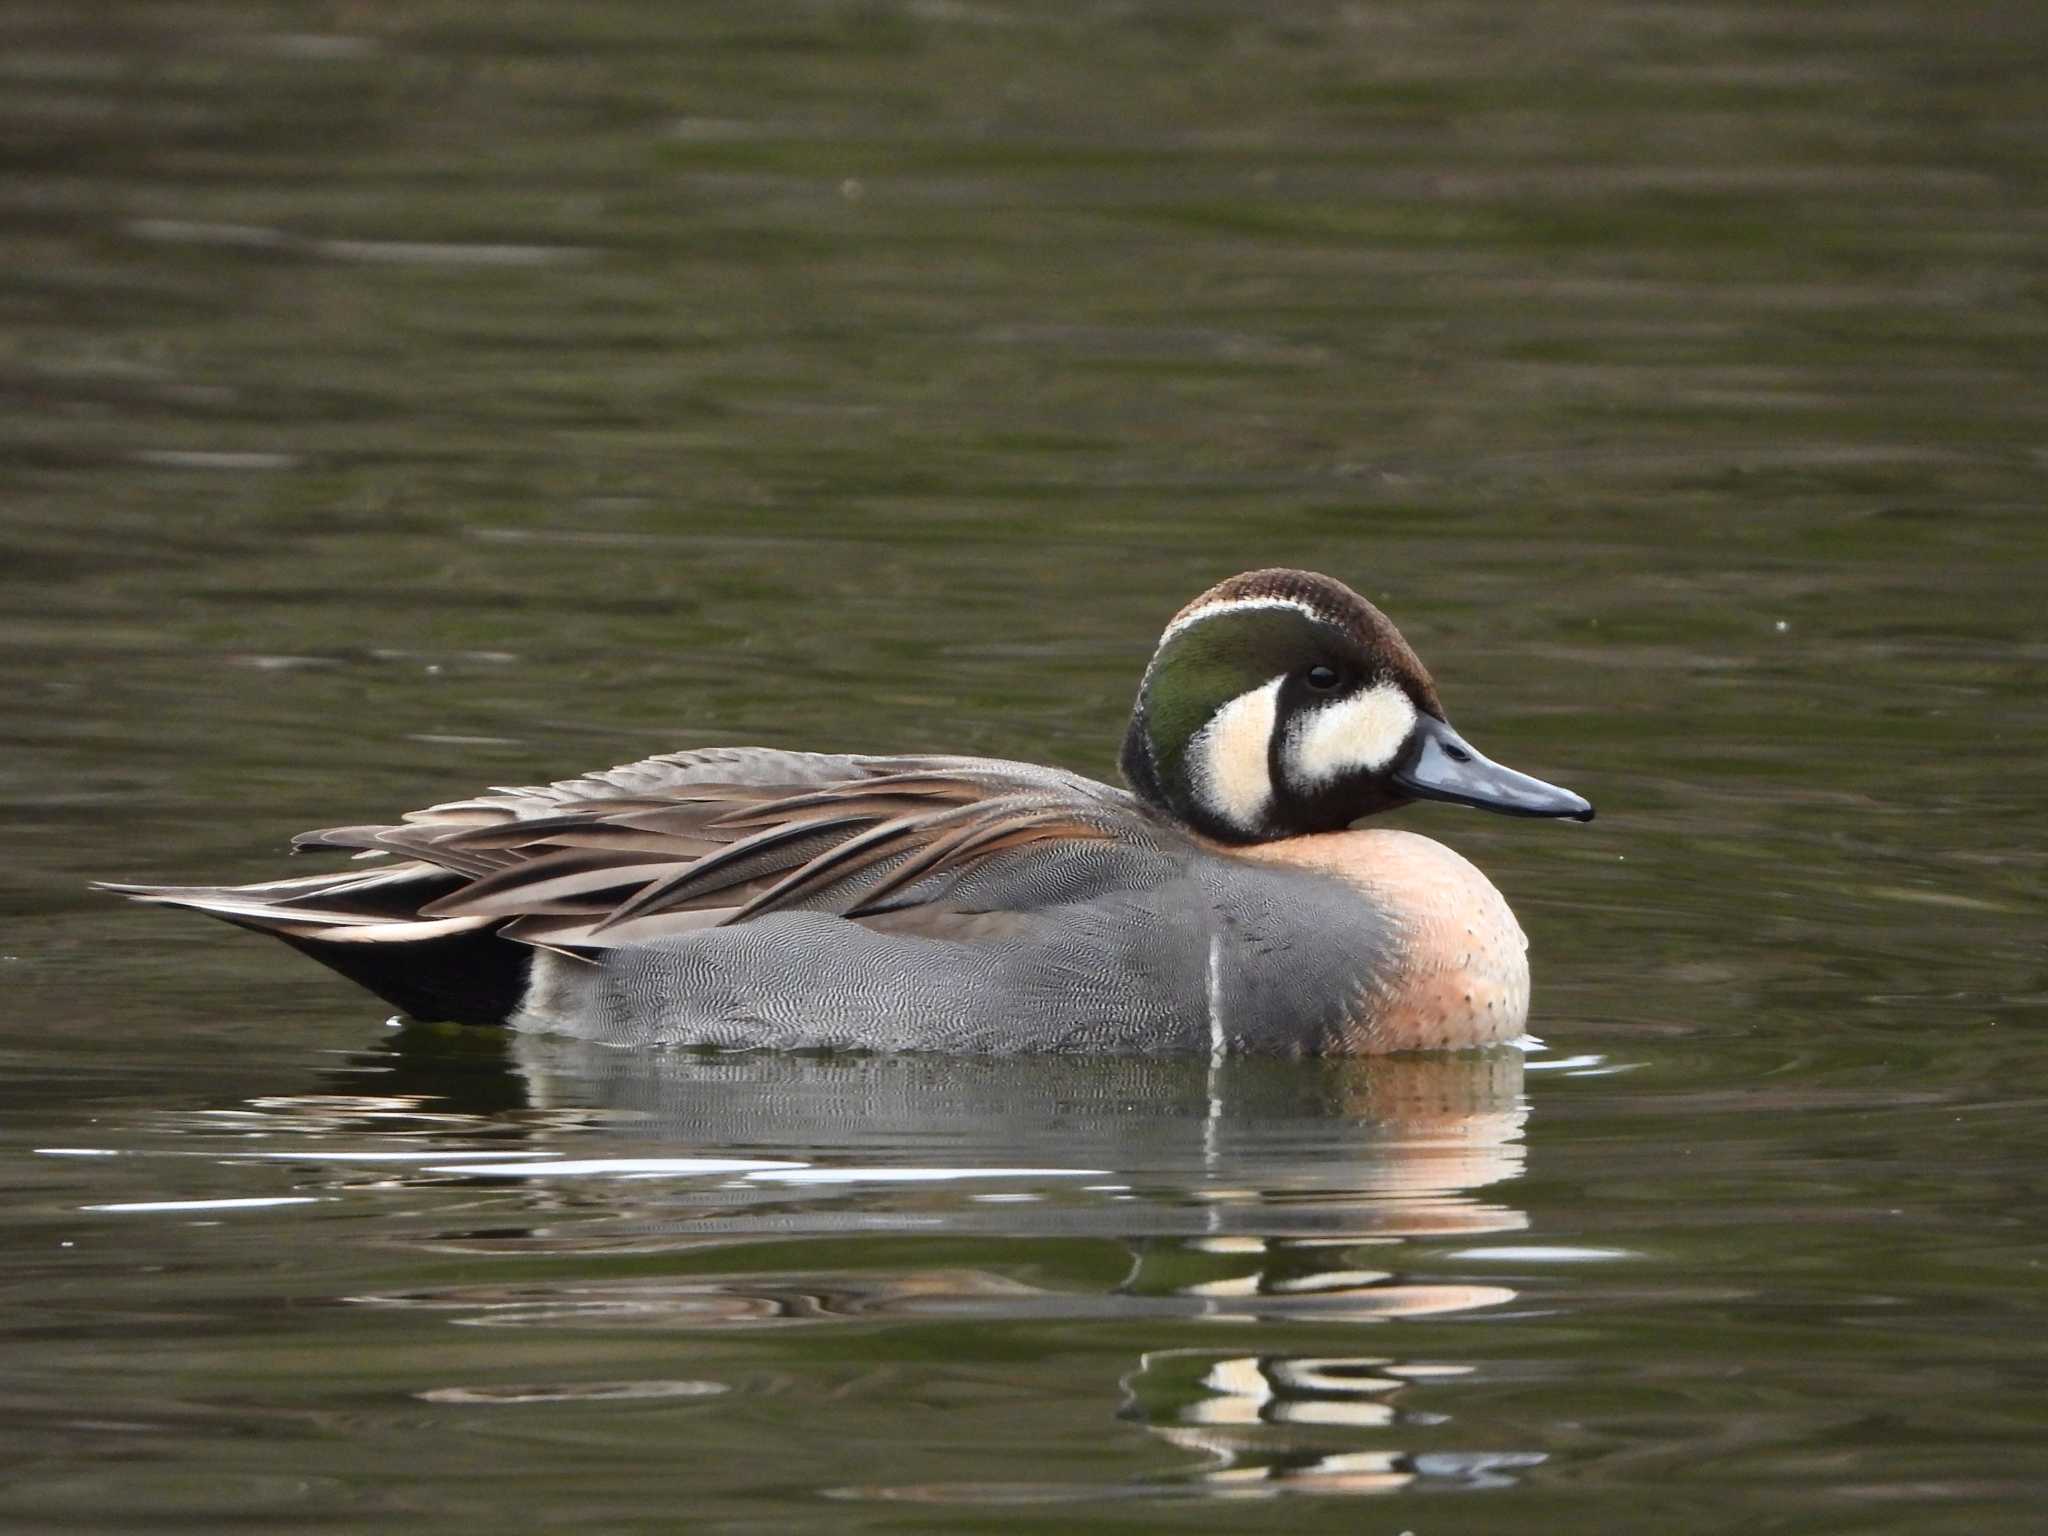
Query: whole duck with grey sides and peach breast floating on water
98 569 1593 1059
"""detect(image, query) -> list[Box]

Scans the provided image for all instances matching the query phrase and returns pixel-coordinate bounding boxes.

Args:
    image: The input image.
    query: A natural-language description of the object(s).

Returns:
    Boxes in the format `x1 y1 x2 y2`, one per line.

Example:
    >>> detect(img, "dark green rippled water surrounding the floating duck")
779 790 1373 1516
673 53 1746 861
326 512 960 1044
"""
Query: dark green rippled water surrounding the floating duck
0 0 2048 1536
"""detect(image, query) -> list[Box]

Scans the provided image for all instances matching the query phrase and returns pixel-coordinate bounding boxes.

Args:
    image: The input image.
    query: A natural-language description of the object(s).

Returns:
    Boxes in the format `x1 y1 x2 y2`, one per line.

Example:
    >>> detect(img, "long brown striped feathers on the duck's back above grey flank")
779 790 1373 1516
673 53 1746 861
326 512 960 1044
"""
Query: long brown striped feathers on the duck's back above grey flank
295 754 1130 952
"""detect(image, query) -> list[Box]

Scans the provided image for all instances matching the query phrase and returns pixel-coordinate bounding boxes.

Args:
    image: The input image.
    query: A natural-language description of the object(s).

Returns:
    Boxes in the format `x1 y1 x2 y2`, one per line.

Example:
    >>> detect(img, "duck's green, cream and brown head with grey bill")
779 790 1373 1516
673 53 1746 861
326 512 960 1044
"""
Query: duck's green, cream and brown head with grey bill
1122 571 1593 842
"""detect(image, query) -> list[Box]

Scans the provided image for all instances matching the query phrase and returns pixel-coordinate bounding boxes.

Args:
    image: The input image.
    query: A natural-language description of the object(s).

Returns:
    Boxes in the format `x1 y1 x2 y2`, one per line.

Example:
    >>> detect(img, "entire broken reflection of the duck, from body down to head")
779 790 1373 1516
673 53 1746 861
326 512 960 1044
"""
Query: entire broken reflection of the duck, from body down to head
303 1036 1532 1499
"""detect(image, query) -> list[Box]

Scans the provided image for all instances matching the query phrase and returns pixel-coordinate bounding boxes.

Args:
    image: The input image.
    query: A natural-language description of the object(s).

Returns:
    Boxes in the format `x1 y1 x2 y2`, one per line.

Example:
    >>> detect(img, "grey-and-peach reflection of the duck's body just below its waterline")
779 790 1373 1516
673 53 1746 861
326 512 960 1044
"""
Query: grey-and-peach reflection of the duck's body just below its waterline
508 1034 1528 1233
